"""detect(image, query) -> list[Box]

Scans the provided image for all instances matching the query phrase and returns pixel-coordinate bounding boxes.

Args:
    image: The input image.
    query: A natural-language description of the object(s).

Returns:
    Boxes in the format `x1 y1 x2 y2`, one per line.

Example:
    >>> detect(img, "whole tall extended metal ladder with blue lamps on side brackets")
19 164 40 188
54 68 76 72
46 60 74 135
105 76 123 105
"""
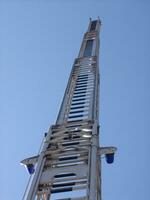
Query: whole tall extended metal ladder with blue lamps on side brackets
21 19 116 200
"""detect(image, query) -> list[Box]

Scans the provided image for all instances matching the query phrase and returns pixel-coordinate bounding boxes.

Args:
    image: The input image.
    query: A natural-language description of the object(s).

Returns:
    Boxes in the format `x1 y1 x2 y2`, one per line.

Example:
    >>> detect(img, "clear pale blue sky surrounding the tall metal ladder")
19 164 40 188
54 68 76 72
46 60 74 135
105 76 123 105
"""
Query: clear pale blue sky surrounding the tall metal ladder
0 0 150 200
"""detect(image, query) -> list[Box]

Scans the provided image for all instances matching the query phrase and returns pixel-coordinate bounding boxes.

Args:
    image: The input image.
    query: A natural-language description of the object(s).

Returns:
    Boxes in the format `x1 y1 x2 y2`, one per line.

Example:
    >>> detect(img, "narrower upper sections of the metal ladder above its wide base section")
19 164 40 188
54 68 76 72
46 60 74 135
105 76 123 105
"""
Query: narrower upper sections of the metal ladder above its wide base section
56 19 101 125
